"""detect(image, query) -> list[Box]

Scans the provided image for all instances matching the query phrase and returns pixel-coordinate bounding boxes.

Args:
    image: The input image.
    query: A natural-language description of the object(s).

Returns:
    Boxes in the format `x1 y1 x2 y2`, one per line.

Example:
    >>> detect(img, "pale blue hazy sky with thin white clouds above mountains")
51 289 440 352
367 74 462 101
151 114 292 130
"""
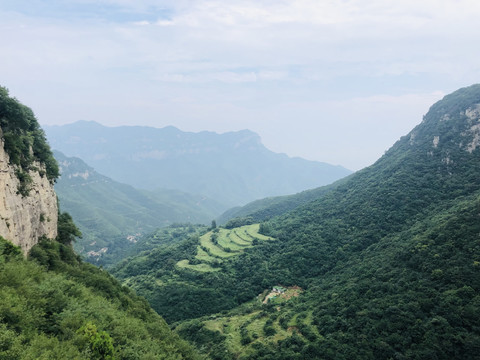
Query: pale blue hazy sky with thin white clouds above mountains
0 0 480 170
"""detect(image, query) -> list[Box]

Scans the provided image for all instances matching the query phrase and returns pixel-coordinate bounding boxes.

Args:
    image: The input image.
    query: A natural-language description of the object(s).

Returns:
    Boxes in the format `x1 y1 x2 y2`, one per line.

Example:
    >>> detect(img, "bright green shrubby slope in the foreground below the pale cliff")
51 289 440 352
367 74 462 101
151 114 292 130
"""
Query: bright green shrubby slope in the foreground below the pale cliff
0 217 197 360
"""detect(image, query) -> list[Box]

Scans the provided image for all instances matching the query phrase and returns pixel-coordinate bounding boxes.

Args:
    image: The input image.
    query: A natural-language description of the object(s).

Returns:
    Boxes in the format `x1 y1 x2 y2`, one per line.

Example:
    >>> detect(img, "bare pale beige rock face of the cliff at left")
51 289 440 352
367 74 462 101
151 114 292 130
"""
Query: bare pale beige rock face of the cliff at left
0 141 58 254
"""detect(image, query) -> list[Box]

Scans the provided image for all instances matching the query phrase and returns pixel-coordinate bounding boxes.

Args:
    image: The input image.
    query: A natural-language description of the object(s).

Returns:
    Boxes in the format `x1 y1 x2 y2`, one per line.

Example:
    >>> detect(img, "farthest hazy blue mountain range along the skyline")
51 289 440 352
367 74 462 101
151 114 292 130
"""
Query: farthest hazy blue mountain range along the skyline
45 121 351 210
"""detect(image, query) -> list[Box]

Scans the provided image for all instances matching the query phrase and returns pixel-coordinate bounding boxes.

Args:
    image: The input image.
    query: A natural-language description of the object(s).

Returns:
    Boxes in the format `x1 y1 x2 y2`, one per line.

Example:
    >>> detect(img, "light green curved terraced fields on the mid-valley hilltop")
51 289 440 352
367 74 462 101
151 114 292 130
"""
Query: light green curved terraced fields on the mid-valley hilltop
177 224 274 272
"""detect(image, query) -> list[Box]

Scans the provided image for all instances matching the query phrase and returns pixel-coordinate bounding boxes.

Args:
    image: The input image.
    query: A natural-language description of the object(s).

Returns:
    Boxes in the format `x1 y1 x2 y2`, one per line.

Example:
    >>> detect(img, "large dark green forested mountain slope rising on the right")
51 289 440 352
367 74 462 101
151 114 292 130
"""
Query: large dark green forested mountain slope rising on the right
111 85 480 359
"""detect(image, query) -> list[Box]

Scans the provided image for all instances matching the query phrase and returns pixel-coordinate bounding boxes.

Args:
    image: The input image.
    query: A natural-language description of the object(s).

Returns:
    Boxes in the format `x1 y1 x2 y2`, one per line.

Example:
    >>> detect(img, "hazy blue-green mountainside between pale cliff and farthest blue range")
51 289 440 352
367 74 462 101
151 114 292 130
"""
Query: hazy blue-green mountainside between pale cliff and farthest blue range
54 151 224 257
